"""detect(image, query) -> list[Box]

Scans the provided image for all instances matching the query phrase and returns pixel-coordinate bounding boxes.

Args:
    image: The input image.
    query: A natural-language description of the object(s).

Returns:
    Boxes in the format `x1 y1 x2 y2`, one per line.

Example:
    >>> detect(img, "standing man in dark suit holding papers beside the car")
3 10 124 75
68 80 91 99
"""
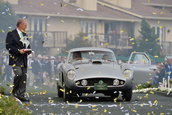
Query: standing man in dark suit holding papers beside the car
6 19 31 101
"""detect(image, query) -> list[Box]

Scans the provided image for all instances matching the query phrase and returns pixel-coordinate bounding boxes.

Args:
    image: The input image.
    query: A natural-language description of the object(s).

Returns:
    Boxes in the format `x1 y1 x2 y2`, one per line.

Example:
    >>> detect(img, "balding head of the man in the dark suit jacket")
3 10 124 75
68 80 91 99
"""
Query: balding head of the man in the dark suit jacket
16 19 27 32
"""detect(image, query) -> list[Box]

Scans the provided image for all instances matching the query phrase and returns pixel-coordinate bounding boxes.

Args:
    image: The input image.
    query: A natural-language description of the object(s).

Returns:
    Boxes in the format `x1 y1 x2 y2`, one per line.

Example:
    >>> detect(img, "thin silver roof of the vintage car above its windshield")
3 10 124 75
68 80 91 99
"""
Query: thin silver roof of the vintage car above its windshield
69 47 113 52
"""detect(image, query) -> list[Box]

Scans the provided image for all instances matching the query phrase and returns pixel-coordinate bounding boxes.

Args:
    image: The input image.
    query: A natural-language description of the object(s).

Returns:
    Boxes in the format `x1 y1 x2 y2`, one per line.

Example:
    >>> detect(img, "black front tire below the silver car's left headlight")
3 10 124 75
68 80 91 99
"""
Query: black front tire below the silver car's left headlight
63 86 72 102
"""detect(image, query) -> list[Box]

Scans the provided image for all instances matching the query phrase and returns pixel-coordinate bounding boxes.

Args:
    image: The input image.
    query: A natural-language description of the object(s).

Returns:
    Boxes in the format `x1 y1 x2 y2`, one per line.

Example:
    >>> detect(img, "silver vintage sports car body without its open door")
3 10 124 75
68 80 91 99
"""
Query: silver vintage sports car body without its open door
57 47 133 101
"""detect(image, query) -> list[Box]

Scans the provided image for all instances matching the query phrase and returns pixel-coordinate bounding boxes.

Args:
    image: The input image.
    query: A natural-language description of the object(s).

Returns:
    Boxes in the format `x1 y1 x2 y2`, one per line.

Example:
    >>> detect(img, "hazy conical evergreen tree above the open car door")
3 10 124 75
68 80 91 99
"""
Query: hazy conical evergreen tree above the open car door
133 19 160 56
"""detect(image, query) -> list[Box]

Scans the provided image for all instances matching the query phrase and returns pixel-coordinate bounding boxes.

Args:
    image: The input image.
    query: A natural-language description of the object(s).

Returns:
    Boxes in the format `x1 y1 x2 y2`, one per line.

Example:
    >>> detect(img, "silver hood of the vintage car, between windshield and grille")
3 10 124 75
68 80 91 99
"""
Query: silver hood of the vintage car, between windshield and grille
75 64 125 80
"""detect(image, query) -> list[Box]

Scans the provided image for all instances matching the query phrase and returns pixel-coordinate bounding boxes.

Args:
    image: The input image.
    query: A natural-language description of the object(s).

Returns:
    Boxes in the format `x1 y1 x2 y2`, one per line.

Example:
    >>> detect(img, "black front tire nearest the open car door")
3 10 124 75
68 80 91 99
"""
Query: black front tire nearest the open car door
122 88 132 101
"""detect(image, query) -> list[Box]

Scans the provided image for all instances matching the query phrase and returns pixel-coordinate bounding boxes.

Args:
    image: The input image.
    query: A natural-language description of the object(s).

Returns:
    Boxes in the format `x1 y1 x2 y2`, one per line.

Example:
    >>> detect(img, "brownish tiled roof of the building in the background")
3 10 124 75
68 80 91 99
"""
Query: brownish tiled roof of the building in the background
13 0 172 21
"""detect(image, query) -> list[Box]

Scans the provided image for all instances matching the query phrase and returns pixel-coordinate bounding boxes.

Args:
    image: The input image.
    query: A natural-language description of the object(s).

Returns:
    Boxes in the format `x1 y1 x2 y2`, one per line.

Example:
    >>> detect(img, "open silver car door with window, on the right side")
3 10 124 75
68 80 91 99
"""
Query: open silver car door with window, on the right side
128 52 156 85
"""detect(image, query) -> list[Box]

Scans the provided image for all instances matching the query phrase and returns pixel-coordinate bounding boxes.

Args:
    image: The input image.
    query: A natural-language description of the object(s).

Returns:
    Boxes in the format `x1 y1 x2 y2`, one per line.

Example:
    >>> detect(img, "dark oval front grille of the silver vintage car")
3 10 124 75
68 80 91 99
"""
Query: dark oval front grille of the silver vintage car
76 78 125 86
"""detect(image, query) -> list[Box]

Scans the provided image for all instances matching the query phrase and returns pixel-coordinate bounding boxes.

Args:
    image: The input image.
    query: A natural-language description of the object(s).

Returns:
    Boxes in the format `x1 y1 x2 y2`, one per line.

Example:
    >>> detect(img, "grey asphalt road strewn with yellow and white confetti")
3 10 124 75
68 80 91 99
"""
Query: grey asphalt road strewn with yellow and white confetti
23 93 172 115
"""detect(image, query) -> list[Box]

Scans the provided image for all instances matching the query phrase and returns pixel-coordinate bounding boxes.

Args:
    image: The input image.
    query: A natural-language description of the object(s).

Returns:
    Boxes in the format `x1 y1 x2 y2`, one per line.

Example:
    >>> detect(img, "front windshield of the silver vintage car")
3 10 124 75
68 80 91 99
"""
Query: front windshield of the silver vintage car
69 51 116 62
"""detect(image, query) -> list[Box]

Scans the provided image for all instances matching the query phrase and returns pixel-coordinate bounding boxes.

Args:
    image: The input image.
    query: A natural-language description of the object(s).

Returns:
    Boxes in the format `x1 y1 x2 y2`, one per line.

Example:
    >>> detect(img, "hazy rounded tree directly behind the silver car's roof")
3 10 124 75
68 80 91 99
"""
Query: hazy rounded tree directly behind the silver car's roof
64 33 92 51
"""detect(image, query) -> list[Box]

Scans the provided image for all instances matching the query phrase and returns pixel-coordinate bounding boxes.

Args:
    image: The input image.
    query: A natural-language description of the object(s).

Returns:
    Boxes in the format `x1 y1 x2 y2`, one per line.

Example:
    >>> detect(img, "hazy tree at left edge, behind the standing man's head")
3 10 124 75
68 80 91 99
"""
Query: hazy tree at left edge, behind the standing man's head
0 0 17 51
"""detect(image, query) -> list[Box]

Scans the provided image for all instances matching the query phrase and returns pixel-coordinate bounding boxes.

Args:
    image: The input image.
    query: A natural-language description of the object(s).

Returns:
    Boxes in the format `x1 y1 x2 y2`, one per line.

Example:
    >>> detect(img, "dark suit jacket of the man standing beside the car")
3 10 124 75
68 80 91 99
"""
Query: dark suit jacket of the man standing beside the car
6 29 30 68
